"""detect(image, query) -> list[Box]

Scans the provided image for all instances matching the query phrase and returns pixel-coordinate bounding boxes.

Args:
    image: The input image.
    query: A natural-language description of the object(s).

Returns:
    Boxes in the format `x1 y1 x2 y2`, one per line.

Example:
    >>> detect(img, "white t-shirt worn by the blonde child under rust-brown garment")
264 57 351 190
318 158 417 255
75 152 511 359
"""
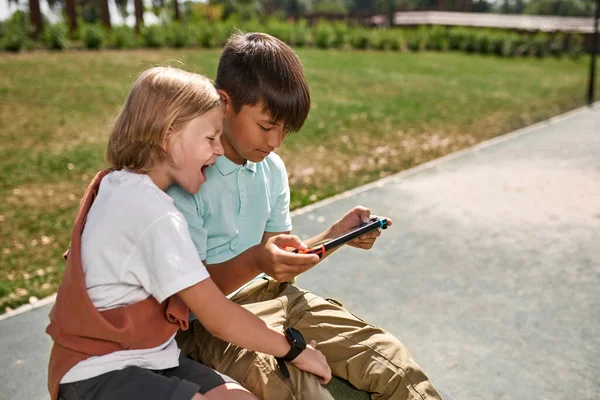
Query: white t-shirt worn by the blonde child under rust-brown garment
61 171 209 383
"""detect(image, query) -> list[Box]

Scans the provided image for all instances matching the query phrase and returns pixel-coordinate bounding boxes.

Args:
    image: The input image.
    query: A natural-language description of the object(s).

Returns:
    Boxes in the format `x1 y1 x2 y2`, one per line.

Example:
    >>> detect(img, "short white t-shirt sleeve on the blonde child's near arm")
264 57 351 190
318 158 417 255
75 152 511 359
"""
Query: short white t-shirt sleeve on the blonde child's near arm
132 212 210 303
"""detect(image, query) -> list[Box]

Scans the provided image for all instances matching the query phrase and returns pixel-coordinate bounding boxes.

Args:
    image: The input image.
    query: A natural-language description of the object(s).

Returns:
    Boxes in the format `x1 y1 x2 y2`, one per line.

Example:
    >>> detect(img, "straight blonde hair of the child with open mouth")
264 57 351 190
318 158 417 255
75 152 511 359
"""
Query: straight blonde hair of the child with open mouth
106 67 222 173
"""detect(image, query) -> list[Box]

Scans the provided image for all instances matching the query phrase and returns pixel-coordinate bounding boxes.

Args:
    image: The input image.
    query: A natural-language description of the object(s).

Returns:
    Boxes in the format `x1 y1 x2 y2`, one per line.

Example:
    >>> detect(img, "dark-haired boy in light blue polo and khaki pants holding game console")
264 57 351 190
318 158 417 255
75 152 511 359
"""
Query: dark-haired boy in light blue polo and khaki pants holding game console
168 33 440 400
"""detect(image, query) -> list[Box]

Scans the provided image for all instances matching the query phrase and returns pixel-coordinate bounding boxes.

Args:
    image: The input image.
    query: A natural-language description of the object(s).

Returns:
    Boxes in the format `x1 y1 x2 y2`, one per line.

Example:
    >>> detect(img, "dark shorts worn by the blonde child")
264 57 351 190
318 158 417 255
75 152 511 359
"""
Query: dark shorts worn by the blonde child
59 354 235 400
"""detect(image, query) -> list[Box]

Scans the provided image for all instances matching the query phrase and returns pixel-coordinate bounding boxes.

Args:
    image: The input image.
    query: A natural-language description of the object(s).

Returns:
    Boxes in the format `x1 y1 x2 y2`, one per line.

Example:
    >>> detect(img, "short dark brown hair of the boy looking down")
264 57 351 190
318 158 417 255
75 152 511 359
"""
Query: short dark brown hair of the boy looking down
215 32 310 132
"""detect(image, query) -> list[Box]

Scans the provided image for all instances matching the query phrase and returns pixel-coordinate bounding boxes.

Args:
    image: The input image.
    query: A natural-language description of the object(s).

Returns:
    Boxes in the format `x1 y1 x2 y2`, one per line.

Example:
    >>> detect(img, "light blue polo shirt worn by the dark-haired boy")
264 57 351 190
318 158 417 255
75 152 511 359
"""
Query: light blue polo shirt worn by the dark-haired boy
167 153 292 270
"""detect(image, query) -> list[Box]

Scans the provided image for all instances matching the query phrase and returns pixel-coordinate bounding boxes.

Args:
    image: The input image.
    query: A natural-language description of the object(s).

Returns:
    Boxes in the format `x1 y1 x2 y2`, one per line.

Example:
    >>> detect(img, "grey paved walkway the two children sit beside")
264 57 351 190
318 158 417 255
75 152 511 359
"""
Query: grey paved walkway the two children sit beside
0 107 600 400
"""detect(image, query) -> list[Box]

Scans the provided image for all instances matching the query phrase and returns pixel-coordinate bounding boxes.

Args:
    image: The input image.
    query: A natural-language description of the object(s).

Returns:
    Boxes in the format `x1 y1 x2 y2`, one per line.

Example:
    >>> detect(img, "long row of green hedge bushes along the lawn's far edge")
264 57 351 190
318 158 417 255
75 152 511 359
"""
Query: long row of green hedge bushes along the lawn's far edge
0 14 583 57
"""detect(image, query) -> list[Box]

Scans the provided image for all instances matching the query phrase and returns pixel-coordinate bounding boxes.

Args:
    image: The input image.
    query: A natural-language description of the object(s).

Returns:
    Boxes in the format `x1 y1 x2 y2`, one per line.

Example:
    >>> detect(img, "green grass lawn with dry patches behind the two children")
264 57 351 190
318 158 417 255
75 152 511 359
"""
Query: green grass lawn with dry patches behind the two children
0 50 600 313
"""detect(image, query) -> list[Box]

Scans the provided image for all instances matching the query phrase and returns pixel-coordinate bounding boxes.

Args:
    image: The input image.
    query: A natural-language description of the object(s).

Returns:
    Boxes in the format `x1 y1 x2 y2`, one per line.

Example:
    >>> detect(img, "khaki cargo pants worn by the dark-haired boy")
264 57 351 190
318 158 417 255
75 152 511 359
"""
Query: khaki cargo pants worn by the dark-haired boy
176 278 441 400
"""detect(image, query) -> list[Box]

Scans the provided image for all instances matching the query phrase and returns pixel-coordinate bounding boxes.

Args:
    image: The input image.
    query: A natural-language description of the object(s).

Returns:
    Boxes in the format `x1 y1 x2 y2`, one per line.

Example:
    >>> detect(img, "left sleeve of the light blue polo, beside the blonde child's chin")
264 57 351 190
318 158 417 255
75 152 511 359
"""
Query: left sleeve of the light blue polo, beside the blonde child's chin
167 185 208 260
